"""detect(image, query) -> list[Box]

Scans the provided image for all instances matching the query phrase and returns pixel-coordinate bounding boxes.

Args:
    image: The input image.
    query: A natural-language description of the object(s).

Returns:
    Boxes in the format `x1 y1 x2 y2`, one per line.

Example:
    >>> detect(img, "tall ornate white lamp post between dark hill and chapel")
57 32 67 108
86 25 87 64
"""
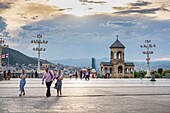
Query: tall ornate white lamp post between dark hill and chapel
31 34 48 71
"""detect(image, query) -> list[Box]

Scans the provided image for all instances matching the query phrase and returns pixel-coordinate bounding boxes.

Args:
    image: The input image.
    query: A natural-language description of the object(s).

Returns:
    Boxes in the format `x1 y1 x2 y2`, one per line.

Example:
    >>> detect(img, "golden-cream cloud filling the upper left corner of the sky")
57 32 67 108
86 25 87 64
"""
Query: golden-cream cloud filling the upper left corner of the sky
0 0 61 37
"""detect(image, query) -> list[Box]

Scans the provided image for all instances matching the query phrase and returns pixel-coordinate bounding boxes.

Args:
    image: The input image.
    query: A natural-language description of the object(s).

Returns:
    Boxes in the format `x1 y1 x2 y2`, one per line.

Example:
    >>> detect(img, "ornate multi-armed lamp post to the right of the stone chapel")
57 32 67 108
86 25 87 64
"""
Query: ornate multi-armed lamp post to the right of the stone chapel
140 40 156 78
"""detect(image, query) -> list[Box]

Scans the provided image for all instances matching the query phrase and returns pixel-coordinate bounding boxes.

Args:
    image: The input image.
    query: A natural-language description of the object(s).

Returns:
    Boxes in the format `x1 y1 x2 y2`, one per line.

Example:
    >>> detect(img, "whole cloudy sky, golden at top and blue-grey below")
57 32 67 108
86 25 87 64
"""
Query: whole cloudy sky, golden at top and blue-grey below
0 0 170 61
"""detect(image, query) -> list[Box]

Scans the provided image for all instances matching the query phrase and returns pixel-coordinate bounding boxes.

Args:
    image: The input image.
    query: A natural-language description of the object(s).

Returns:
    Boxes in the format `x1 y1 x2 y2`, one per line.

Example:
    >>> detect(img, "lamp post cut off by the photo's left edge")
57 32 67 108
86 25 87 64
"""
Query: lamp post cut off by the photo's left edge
0 35 9 72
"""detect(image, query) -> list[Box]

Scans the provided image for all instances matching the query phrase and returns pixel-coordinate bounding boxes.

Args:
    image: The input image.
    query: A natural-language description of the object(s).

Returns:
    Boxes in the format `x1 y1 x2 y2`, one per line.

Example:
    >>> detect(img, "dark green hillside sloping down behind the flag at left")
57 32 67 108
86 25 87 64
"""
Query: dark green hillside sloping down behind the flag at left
2 48 51 65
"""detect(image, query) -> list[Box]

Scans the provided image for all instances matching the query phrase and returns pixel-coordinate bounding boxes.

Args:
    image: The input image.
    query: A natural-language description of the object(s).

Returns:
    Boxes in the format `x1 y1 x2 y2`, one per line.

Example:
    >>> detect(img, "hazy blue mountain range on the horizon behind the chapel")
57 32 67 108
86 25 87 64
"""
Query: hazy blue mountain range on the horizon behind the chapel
51 58 170 71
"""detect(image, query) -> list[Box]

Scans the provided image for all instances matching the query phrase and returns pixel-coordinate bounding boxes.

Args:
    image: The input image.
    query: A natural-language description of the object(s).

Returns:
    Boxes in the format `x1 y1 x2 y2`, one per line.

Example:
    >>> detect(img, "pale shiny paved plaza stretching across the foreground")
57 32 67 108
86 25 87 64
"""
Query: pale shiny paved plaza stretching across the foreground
0 78 170 113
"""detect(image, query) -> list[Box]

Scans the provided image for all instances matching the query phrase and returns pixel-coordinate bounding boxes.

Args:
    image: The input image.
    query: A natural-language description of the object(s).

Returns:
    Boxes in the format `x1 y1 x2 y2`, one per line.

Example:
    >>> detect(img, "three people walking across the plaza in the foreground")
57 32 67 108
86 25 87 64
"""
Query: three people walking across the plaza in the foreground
19 68 63 97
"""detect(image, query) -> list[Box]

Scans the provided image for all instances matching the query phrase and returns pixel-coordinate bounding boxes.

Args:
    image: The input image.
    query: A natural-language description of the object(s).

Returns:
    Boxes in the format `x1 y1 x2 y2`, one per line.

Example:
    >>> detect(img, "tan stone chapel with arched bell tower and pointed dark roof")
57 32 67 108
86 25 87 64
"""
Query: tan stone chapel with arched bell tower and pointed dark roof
100 36 134 78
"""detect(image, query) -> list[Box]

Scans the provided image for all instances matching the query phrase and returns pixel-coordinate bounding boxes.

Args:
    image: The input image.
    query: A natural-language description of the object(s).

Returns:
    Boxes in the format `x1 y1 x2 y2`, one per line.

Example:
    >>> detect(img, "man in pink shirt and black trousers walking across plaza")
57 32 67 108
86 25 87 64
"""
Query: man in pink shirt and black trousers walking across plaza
42 68 54 97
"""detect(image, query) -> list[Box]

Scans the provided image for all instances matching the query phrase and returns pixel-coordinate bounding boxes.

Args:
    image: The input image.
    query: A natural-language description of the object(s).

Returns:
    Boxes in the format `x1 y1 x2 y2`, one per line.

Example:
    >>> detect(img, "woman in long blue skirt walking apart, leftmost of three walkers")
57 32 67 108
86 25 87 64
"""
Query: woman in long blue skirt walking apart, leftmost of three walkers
19 70 26 96
